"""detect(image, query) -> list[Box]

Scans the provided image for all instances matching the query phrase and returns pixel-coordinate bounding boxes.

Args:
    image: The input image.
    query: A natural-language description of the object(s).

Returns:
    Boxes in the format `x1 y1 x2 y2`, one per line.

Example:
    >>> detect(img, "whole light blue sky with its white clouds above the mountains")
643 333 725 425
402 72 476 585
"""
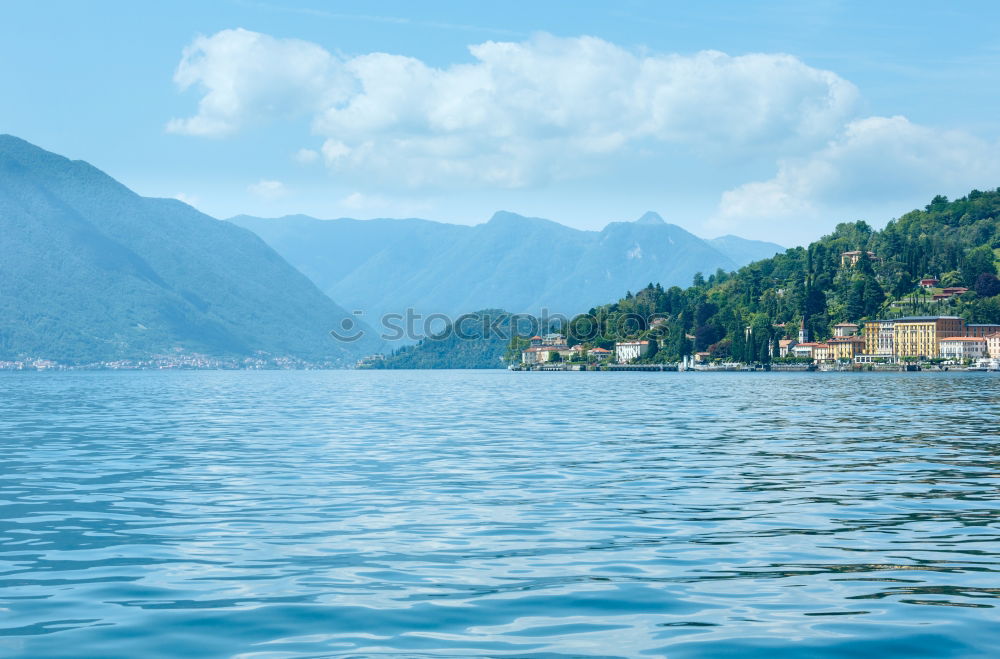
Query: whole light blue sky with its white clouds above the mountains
0 0 1000 245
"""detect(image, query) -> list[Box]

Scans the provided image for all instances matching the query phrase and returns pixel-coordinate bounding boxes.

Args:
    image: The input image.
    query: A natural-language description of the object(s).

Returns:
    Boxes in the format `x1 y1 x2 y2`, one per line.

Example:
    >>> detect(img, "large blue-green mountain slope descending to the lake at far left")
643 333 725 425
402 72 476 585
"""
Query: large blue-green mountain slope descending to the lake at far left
0 135 372 362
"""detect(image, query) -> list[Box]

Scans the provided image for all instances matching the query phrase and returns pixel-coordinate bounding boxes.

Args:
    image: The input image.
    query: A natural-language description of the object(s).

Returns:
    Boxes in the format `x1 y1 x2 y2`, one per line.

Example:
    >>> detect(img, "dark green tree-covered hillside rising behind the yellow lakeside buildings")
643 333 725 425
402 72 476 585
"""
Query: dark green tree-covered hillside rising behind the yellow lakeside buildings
568 189 1000 362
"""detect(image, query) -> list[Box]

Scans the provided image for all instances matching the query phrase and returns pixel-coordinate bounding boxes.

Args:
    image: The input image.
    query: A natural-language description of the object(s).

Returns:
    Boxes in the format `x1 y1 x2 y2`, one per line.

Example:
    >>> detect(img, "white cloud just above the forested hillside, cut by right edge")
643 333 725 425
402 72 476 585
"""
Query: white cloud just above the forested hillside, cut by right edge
711 116 1000 242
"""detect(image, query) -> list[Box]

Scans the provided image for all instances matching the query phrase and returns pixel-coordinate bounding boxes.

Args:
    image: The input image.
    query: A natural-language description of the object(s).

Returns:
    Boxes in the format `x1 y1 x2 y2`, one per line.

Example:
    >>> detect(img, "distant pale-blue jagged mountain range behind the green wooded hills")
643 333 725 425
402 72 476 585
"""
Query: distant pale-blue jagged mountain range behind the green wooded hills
230 211 780 319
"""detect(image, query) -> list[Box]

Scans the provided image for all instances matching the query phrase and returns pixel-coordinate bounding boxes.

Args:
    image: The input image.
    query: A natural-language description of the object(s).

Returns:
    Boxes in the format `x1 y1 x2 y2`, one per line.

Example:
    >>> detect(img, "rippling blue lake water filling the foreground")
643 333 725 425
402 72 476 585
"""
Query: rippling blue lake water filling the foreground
0 371 1000 658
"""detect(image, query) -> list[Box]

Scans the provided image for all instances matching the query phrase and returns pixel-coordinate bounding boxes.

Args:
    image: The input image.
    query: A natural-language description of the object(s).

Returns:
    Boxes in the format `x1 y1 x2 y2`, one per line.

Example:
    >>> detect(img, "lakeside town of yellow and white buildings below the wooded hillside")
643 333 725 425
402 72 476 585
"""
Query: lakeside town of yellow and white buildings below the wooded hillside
510 316 1000 371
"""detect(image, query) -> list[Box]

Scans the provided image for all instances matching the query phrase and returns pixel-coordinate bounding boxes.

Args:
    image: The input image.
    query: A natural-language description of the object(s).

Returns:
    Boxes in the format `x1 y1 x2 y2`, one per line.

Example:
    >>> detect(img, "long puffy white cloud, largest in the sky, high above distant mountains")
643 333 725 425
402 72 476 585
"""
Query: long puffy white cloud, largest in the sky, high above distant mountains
168 30 858 187
